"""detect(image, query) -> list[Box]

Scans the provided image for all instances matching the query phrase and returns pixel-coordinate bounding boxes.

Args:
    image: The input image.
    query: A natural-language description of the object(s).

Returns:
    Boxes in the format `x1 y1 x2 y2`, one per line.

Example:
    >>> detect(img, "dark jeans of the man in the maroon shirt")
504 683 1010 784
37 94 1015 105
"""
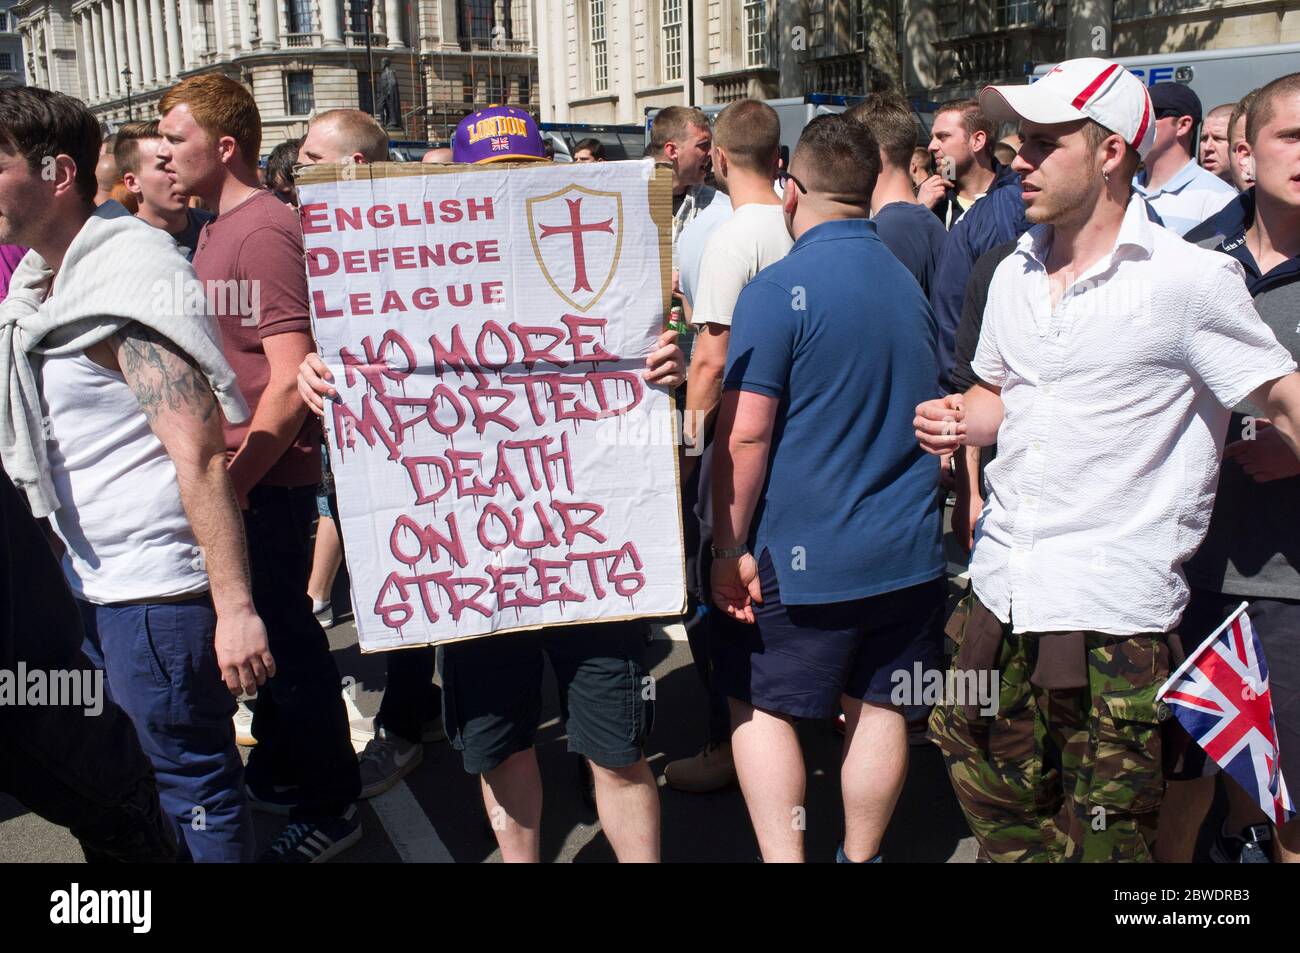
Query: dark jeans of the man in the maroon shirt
244 485 361 818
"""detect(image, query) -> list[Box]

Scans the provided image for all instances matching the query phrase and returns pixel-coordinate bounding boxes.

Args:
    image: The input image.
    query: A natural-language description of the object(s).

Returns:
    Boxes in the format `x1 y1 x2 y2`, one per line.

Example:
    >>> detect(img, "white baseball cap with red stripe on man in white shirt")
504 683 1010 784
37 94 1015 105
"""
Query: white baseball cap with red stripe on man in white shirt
979 56 1156 159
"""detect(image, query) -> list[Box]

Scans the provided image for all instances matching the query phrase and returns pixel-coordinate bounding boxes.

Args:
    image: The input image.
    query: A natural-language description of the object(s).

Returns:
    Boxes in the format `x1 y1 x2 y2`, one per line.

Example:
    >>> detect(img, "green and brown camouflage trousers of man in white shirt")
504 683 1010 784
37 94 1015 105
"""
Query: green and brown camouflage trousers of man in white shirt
930 597 1169 862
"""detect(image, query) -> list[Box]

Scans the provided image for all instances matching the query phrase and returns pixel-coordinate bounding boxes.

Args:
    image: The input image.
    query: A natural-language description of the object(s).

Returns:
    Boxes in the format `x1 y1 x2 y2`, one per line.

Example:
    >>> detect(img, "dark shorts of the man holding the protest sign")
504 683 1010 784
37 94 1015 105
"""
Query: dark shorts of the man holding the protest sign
438 620 654 775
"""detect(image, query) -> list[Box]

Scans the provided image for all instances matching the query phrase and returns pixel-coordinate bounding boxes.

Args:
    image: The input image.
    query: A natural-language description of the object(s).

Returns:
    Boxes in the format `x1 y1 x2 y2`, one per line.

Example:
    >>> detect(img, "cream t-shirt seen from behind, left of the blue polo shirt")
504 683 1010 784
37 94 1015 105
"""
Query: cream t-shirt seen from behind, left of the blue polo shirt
690 204 794 326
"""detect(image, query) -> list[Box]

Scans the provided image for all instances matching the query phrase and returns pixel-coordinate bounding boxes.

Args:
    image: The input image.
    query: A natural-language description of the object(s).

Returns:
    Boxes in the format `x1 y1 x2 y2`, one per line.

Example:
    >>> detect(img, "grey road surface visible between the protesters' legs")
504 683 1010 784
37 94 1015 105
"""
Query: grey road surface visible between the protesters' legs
0 512 975 863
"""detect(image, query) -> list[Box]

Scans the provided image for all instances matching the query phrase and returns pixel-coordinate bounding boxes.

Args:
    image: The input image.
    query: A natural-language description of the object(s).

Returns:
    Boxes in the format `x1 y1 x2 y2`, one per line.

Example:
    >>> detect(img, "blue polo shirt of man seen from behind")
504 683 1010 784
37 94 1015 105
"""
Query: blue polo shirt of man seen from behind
723 220 944 605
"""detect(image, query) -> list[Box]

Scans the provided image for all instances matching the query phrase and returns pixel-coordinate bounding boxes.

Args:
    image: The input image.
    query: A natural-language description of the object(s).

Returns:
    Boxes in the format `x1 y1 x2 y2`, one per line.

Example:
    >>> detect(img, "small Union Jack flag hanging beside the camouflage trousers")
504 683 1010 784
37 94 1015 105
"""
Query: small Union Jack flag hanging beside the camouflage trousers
1157 602 1296 824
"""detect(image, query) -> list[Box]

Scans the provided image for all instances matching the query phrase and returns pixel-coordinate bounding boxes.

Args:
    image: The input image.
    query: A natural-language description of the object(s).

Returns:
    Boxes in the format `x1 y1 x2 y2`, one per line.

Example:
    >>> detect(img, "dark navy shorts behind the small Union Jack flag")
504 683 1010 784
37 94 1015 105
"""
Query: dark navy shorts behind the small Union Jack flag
1162 586 1300 796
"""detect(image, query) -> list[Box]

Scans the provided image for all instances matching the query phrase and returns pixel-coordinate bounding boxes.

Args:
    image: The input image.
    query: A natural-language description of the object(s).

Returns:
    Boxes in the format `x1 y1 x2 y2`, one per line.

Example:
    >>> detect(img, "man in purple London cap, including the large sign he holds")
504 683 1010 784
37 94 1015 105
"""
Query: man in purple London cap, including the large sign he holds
299 107 684 861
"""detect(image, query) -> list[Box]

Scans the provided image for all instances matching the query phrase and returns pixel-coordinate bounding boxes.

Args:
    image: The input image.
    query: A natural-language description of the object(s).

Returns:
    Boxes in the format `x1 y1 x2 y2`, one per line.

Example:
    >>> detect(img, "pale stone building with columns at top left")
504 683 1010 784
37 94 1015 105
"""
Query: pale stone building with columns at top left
12 0 538 153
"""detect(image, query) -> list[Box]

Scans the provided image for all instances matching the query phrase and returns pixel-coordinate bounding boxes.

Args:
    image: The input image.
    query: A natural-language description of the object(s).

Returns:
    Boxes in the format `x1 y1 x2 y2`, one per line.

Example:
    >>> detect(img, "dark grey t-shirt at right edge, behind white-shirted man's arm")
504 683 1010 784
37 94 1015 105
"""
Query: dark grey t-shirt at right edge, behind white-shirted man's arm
1183 213 1300 599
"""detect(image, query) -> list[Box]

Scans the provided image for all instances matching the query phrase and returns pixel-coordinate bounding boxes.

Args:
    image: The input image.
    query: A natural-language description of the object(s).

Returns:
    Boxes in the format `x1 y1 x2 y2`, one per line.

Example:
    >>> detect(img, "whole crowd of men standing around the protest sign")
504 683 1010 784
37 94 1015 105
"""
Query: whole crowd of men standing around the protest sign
0 59 1300 863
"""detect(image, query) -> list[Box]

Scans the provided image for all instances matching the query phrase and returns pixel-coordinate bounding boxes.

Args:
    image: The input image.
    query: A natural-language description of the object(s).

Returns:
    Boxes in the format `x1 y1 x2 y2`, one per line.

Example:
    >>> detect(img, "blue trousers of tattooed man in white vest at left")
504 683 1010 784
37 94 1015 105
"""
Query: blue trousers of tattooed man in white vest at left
79 594 256 863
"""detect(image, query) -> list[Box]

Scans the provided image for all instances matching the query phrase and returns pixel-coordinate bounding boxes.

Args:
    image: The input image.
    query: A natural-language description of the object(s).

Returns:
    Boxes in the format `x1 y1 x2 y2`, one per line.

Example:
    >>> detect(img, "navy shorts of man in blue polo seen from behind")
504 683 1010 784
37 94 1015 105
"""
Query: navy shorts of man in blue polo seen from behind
712 550 946 720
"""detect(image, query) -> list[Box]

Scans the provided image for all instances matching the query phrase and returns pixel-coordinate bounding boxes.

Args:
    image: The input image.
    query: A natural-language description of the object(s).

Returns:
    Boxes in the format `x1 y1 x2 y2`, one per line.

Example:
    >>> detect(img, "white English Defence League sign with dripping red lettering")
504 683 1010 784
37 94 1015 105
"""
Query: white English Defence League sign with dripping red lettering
298 161 685 651
